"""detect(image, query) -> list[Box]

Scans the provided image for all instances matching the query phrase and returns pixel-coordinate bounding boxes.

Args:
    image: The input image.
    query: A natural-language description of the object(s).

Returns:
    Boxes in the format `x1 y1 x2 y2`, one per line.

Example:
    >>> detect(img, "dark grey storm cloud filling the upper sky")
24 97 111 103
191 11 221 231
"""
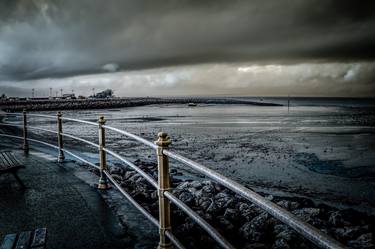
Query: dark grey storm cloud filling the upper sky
0 0 375 79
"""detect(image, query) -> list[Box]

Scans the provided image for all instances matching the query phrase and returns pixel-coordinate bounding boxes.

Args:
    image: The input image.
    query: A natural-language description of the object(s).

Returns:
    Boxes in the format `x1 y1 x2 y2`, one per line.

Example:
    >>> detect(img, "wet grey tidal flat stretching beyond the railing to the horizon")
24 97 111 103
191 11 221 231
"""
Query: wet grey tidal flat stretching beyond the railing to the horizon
16 99 375 214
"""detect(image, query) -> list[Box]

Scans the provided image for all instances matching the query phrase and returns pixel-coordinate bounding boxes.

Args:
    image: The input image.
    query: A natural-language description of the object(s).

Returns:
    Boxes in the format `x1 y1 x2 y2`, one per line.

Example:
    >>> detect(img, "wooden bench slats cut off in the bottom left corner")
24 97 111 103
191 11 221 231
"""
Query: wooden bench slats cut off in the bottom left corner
0 228 47 249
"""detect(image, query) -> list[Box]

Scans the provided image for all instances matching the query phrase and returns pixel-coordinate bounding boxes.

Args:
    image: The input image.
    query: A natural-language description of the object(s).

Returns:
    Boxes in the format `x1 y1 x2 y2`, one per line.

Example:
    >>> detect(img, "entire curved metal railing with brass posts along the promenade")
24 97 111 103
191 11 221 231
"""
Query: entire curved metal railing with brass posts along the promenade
0 111 345 249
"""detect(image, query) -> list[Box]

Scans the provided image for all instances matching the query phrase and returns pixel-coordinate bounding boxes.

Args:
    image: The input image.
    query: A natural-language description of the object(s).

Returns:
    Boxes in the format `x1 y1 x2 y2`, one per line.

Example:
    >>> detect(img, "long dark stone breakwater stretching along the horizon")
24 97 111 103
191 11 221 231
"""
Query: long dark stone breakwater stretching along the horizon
0 97 281 112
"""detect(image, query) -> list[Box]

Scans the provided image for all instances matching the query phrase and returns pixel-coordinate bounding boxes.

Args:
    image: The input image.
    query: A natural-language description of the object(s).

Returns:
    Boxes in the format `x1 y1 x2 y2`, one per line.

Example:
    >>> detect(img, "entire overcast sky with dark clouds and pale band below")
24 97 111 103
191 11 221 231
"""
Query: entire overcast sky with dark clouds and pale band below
0 0 375 97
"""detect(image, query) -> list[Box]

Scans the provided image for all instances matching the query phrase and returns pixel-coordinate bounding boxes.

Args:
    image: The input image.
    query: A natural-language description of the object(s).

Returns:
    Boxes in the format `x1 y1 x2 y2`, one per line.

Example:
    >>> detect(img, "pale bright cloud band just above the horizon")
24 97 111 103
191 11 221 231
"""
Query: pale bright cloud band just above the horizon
3 62 375 97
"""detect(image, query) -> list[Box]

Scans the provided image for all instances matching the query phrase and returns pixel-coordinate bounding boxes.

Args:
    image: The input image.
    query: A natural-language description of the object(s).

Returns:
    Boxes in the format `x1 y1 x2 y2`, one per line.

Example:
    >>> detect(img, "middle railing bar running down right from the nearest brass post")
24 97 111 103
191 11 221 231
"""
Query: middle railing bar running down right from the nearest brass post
164 191 235 249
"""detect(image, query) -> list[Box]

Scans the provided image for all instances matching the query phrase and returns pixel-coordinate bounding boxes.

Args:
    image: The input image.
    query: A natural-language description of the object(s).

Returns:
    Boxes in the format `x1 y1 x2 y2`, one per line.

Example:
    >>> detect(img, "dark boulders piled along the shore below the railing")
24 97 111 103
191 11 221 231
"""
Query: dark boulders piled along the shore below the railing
88 160 375 249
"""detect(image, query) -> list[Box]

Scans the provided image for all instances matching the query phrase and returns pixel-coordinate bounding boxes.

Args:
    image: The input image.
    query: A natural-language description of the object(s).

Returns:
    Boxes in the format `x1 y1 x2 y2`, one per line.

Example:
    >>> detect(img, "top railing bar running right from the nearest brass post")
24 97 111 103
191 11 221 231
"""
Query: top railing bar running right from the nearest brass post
163 150 345 249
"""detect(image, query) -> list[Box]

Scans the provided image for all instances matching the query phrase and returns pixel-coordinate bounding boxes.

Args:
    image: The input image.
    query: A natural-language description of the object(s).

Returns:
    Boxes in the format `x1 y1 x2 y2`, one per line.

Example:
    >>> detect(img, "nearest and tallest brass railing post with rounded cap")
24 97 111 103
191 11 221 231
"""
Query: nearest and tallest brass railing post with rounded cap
155 132 173 249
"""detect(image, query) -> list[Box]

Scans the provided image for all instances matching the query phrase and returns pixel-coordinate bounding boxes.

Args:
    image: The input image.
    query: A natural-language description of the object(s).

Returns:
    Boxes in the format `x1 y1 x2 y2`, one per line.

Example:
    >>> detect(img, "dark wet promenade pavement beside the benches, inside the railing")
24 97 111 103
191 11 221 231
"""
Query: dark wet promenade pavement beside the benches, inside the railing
0 147 131 249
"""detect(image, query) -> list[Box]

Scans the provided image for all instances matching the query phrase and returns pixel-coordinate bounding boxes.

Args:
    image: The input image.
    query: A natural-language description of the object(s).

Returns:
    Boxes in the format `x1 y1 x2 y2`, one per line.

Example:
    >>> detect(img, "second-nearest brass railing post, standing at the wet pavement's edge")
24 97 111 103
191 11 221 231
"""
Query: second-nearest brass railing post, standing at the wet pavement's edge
98 116 109 189
